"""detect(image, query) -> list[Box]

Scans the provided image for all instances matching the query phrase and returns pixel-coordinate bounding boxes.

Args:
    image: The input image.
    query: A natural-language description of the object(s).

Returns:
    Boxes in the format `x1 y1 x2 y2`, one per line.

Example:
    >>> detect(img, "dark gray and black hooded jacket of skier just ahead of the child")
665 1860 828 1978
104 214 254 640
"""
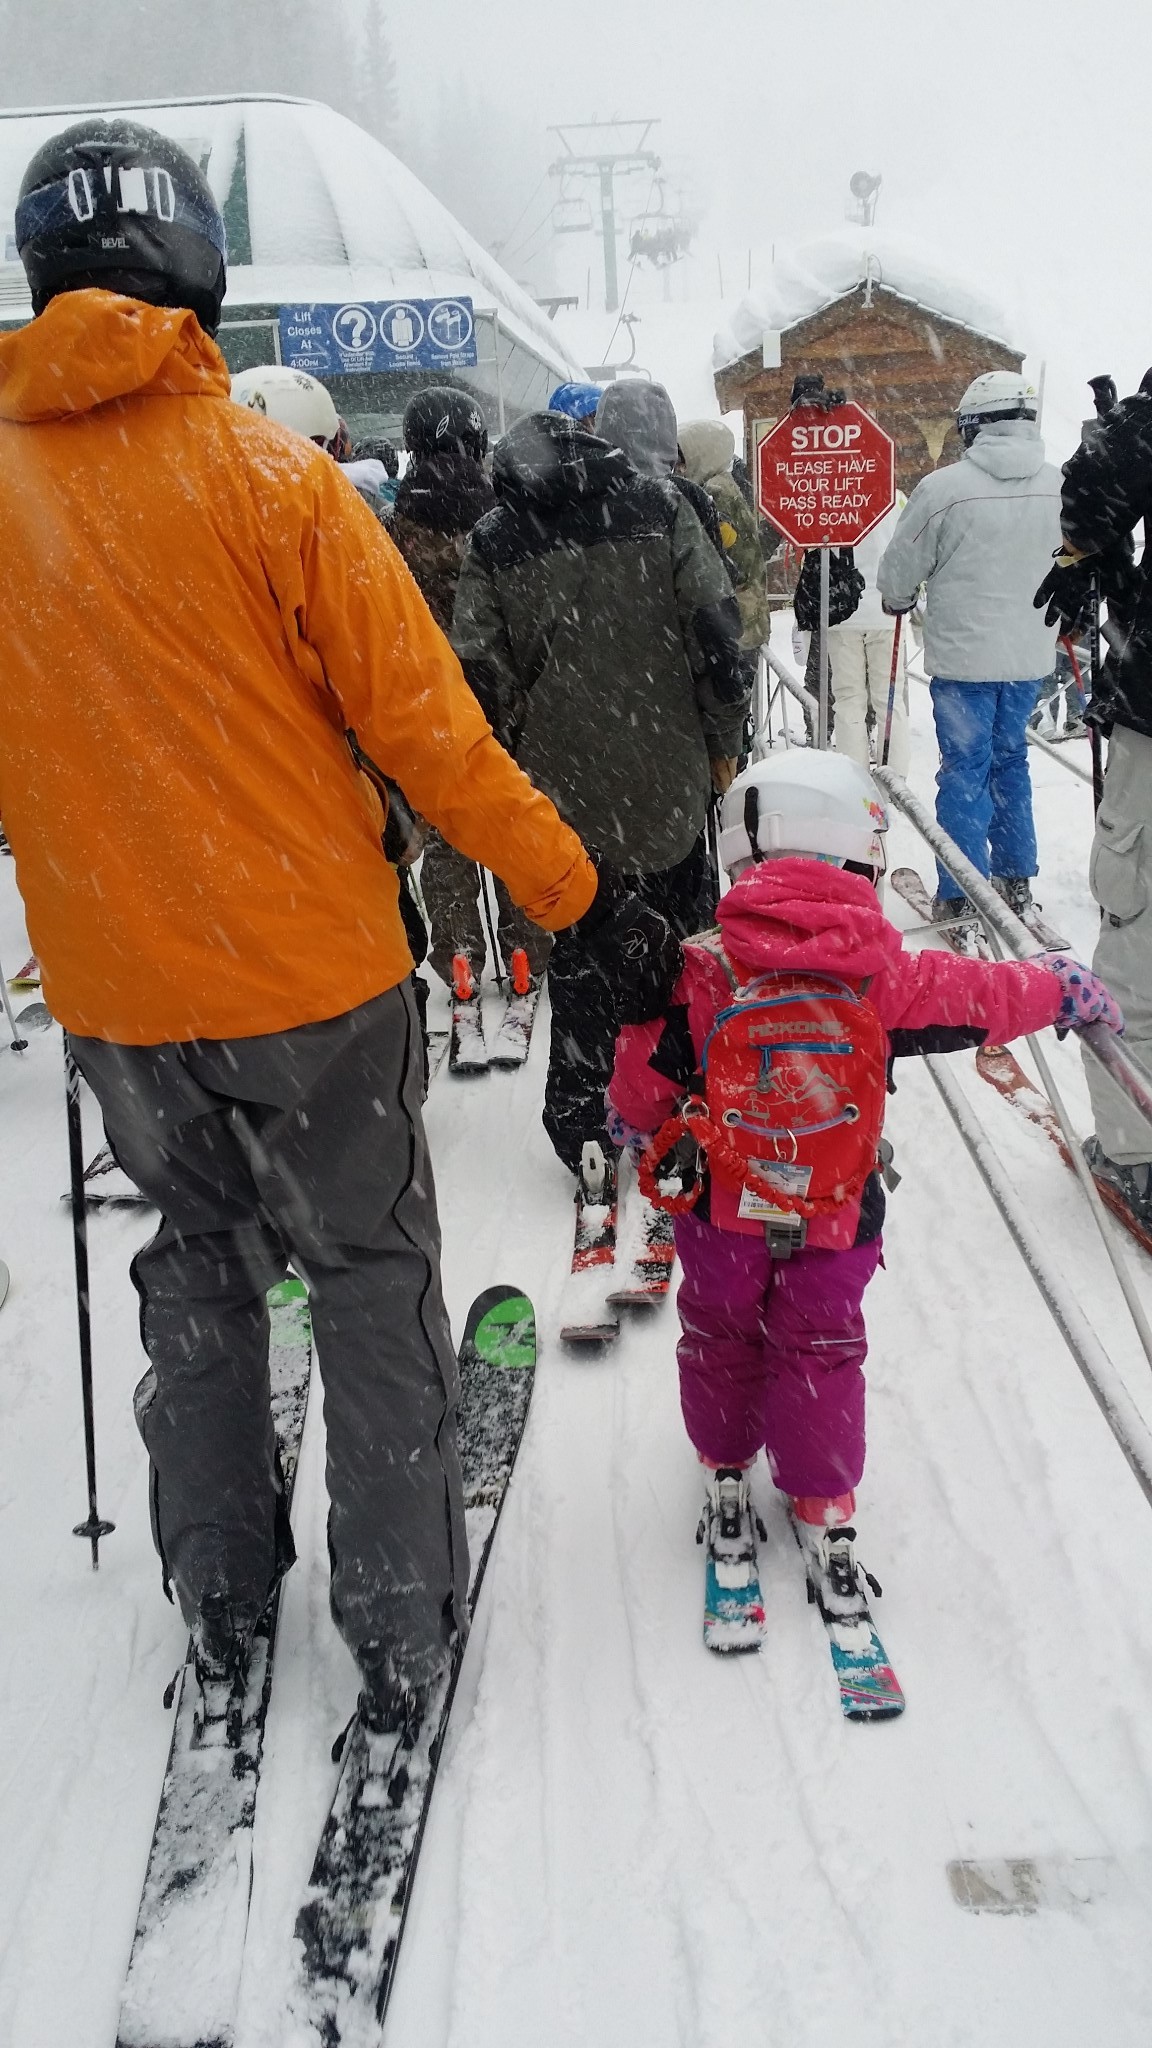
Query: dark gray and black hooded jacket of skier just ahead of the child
451 414 750 874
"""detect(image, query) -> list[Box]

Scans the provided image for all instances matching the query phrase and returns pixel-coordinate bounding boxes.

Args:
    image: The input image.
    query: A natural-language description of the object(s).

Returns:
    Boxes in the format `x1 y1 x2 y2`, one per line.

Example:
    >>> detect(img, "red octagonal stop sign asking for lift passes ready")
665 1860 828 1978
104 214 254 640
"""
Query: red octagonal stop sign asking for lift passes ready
756 401 896 547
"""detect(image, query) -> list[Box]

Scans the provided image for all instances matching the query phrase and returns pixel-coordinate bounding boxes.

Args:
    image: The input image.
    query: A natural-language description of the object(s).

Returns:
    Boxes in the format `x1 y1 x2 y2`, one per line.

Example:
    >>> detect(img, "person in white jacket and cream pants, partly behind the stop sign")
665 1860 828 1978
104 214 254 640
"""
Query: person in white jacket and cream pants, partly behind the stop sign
828 496 908 774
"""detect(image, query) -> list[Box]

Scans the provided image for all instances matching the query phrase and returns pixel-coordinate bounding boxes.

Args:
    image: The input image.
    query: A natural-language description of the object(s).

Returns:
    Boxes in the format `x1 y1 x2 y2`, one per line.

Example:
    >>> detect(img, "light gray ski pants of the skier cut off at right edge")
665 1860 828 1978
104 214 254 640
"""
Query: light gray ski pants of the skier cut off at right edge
1084 725 1152 1165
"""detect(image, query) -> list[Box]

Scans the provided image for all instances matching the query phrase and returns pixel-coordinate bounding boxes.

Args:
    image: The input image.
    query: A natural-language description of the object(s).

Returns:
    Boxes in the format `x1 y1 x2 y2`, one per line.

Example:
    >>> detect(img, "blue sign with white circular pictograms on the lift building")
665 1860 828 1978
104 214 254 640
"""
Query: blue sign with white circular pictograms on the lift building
281 299 478 377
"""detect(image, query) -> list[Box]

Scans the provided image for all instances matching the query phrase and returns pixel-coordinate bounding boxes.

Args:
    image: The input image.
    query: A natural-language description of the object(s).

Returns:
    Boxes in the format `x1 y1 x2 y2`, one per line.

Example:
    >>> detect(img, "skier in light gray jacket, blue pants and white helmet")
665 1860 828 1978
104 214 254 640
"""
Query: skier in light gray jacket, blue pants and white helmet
879 371 1060 918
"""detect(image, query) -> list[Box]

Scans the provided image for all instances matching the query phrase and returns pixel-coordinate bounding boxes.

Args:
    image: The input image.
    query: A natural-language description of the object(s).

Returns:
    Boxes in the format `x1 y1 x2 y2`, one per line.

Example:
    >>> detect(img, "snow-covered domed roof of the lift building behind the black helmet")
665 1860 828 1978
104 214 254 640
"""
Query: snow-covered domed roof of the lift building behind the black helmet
0 94 582 379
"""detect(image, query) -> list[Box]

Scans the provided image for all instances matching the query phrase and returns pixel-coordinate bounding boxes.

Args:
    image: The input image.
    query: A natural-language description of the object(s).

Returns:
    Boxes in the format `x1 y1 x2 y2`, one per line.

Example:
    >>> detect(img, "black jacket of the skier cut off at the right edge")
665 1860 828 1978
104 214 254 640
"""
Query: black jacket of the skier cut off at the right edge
1060 391 1152 739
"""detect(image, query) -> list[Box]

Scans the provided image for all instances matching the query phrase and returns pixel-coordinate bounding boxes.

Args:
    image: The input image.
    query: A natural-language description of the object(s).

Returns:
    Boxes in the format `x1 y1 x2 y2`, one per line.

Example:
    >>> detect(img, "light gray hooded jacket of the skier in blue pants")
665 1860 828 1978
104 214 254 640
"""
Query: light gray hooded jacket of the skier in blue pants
877 420 1060 682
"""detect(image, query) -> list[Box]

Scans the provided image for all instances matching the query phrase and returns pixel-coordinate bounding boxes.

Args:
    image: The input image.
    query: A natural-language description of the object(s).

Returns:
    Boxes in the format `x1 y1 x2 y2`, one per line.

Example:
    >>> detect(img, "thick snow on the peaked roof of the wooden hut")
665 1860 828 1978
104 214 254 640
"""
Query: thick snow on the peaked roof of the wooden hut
713 227 1009 371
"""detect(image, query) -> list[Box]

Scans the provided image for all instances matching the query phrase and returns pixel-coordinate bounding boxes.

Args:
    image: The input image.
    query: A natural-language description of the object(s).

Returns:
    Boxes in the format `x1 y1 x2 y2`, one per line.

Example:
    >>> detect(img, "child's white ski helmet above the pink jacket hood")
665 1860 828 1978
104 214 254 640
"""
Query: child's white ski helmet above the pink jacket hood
719 748 888 874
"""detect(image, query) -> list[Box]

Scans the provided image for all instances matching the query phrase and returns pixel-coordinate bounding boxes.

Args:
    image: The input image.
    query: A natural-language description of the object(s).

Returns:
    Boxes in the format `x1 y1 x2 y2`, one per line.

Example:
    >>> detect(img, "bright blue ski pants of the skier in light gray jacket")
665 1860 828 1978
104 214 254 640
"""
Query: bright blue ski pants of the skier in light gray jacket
933 676 1043 897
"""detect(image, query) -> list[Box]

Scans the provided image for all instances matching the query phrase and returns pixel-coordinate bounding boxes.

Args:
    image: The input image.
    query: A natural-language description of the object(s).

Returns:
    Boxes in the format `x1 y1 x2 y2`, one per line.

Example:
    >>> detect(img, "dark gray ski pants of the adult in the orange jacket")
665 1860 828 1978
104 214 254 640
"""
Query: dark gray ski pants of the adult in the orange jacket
70 981 467 1683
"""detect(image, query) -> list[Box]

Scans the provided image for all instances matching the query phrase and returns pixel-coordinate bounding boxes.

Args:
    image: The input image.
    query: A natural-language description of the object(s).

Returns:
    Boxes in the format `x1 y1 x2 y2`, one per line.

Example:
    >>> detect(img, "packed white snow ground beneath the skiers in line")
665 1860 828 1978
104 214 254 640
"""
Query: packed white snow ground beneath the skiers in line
0 649 1152 2048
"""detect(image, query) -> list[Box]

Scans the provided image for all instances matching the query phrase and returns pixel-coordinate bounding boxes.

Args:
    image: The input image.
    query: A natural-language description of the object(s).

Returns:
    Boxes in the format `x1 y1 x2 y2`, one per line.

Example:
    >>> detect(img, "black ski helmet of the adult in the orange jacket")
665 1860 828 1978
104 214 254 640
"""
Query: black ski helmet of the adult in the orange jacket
16 115 228 334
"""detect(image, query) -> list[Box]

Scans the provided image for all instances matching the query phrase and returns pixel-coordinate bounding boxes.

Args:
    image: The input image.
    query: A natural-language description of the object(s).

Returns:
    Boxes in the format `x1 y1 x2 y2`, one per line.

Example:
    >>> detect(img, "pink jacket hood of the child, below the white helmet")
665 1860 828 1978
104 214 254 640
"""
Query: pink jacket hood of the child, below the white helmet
717 860 902 981
